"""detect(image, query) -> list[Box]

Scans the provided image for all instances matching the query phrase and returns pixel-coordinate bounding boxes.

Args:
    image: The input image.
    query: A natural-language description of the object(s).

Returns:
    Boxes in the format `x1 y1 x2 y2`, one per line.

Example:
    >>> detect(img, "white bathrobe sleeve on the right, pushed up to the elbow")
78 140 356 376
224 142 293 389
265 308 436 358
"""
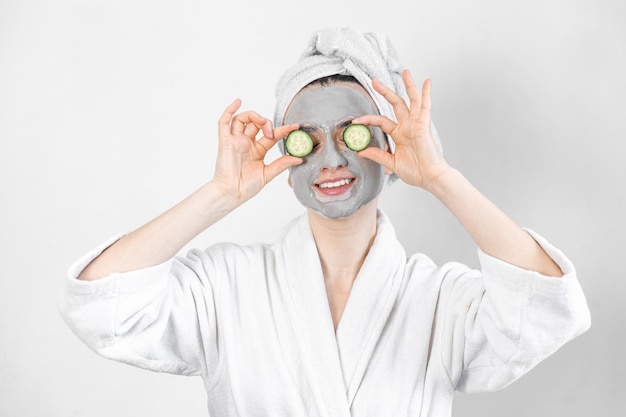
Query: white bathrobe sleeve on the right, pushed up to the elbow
439 231 590 392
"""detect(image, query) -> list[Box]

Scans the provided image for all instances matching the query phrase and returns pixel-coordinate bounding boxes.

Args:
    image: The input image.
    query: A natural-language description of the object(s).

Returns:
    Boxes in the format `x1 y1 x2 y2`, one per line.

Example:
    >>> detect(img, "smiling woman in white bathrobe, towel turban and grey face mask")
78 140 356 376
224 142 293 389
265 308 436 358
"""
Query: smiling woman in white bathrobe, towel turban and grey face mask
61 28 589 417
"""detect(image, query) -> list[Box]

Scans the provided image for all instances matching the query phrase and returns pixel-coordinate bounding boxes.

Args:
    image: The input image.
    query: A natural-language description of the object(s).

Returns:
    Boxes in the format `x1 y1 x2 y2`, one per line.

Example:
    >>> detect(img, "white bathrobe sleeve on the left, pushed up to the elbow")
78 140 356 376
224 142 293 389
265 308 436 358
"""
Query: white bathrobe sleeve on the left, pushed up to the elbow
59 237 218 375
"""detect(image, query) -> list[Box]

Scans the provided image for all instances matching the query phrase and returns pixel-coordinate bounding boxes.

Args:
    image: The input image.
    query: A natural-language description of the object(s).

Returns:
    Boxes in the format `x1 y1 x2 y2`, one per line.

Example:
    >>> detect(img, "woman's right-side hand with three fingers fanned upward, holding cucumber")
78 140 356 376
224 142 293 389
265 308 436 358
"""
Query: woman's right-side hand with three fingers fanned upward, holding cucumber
352 70 449 189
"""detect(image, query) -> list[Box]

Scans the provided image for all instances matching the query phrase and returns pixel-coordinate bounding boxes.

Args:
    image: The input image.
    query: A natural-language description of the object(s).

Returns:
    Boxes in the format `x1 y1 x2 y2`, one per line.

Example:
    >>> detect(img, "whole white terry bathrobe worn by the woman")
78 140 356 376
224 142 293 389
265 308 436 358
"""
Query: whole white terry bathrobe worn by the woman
60 212 590 417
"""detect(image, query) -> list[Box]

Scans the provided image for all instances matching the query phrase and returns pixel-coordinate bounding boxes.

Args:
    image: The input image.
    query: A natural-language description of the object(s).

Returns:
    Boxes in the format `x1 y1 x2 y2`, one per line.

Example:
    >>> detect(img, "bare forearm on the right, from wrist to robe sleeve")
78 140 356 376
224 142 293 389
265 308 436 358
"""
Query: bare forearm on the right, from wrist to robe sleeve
429 168 563 276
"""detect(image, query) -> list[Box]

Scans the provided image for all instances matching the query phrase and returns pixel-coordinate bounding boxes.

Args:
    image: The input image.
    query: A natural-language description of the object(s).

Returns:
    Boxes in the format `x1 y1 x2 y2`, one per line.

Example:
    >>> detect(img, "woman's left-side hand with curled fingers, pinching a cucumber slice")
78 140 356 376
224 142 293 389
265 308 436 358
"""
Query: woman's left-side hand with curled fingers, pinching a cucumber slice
212 99 302 205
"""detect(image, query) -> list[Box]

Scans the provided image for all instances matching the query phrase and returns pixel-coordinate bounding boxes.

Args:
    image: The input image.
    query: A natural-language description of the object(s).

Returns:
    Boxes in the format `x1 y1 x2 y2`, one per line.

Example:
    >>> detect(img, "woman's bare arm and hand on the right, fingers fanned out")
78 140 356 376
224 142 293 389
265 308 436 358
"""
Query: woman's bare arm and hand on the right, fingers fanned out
353 70 563 276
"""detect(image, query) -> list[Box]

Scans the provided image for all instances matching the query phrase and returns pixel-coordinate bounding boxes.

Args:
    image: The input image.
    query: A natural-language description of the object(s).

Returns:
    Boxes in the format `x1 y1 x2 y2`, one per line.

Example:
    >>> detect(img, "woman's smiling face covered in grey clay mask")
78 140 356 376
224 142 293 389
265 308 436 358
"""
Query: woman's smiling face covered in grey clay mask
284 83 386 219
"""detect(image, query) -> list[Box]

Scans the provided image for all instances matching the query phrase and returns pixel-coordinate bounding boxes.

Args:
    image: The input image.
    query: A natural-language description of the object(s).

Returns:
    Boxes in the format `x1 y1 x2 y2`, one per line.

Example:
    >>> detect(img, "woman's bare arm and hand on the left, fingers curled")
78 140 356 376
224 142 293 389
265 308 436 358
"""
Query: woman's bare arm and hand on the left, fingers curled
78 100 302 280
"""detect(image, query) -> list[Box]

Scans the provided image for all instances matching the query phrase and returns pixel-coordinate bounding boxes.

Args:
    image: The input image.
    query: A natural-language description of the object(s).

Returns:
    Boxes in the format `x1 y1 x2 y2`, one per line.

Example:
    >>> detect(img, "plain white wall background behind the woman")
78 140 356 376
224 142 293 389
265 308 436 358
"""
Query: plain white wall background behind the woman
0 0 626 417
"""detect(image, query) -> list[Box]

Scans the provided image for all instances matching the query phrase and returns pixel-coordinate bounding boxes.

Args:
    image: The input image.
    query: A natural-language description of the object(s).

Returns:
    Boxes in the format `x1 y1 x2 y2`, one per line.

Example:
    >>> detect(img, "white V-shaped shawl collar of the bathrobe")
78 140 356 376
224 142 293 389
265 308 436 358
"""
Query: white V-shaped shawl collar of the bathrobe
279 210 406 416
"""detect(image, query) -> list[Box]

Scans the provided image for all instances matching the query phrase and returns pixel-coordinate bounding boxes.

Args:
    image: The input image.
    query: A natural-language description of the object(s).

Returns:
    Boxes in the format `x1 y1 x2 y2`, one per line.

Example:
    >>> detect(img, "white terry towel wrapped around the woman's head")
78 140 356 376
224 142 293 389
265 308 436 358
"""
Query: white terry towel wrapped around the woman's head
274 27 441 156
